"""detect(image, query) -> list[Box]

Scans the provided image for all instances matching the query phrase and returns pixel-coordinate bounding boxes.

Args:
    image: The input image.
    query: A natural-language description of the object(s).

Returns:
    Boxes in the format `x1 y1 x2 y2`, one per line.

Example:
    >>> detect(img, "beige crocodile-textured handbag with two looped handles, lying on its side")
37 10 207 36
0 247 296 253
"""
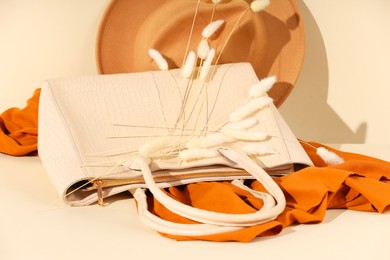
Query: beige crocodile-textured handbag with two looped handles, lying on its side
38 63 311 235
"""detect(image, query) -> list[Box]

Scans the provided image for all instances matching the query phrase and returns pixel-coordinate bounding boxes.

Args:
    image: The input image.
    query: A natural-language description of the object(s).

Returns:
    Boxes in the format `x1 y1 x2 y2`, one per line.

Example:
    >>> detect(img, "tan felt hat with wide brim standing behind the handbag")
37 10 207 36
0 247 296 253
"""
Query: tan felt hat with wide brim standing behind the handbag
96 0 305 106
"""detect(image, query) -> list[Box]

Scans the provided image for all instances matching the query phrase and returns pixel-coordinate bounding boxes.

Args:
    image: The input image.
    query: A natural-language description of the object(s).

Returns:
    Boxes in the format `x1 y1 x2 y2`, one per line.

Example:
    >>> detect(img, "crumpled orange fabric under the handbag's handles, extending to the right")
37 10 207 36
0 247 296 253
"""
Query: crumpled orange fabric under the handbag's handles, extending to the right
148 143 390 242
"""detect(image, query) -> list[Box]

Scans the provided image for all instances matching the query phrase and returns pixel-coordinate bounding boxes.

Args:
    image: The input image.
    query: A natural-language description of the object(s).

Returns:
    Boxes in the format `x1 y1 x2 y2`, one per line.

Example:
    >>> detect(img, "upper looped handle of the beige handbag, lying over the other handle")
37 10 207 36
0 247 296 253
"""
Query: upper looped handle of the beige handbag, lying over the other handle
129 148 286 227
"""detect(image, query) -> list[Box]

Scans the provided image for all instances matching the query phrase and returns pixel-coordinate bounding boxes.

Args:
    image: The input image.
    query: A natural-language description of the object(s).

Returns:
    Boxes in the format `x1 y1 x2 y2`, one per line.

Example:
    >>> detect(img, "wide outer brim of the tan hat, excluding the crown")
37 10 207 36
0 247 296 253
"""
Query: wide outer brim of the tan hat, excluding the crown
96 0 305 106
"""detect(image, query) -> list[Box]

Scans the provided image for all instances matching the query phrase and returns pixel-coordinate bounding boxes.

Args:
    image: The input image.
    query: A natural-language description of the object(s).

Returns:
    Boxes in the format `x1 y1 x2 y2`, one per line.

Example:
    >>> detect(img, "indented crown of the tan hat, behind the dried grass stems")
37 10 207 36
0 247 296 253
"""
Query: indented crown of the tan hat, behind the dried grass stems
132 0 268 71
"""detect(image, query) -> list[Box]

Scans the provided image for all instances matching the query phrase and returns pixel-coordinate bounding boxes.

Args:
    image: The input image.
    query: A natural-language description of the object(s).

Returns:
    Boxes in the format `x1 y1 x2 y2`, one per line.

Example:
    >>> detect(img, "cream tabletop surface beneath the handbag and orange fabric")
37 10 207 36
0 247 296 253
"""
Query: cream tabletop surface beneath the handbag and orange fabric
0 144 390 260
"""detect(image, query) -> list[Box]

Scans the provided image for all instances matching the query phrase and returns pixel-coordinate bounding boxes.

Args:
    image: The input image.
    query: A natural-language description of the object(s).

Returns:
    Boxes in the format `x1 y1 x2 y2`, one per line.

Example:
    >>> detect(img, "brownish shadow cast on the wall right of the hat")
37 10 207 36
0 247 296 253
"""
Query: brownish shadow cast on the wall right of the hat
279 0 367 143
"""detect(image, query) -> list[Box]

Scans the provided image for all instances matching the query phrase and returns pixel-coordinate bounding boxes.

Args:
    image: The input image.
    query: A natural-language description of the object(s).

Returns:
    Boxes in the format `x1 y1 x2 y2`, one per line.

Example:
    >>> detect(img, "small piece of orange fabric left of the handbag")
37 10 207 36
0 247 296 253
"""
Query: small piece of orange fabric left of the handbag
0 89 41 156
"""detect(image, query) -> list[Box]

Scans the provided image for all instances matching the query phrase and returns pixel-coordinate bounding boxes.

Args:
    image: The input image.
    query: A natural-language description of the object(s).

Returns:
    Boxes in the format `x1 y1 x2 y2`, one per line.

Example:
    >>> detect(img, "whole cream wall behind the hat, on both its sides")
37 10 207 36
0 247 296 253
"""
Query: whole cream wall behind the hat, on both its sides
0 0 390 143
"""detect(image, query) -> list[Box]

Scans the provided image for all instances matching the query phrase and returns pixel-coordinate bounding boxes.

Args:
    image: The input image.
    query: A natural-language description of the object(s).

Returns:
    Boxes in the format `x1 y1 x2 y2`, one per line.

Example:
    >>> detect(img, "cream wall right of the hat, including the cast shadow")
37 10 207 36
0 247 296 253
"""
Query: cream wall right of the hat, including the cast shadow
281 0 390 143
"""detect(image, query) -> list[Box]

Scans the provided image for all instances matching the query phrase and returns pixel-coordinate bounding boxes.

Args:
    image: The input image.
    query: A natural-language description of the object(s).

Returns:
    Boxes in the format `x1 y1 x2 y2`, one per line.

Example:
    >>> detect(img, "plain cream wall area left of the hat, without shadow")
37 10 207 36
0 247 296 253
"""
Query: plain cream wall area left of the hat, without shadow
0 0 109 108
